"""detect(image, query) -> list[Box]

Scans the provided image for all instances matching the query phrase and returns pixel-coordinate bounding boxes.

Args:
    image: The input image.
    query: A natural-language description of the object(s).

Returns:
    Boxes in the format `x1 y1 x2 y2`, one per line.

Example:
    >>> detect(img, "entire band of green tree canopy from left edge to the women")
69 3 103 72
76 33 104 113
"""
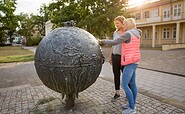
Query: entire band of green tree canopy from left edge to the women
0 0 128 45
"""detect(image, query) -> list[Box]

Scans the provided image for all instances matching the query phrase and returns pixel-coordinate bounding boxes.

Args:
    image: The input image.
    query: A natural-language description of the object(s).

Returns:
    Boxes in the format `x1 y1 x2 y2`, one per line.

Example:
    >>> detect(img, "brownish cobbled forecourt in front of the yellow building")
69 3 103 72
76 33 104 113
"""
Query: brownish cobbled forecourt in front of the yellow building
102 47 185 77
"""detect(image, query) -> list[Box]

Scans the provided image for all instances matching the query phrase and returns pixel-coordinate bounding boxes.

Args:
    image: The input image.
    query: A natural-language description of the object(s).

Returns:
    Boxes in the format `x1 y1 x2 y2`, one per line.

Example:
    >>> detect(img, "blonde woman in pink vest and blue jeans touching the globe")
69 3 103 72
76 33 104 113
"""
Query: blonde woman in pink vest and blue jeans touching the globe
100 18 141 114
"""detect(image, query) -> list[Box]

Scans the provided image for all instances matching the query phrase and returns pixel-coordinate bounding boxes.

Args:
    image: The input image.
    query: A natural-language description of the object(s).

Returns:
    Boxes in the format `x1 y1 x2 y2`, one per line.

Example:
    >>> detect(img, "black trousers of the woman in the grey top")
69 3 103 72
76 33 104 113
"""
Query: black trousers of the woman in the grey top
112 54 123 90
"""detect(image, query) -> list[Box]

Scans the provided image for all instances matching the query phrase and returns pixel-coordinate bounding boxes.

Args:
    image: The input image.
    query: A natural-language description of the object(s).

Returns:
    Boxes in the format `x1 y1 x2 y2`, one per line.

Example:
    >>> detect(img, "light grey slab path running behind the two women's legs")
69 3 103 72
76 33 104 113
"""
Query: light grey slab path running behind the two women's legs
100 62 185 106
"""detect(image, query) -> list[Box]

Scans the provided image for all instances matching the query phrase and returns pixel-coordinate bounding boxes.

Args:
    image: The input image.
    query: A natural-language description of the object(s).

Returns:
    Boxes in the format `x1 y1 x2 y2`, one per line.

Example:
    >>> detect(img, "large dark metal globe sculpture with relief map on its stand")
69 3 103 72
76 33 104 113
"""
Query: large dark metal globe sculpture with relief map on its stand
35 22 104 109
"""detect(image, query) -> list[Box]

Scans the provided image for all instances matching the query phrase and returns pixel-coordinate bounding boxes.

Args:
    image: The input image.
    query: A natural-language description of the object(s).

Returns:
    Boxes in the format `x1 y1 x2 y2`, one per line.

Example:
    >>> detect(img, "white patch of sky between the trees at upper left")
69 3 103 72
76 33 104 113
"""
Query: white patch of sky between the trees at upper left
14 0 52 15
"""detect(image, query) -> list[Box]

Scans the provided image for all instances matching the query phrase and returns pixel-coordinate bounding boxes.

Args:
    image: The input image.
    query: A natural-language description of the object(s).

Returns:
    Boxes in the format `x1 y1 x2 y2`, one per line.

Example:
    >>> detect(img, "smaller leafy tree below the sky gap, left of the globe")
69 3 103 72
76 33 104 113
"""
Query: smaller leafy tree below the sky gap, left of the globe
18 13 45 46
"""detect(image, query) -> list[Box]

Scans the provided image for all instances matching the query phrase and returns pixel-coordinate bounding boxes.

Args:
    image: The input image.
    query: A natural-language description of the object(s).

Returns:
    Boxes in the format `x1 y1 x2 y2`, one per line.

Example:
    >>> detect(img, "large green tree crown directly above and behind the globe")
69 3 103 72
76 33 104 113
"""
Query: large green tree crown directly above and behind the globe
46 0 127 38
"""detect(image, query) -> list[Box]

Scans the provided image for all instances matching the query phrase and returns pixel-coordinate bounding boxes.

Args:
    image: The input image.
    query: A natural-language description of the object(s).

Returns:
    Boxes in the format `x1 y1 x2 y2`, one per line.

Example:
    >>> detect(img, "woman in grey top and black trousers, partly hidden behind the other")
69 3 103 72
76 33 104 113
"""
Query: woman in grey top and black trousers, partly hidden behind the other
109 16 125 100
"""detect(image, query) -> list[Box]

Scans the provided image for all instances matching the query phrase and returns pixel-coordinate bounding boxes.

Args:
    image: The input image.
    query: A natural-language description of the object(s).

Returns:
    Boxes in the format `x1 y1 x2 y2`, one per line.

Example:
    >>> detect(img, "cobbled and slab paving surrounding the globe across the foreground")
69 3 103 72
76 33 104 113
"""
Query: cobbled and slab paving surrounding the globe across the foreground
0 46 185 114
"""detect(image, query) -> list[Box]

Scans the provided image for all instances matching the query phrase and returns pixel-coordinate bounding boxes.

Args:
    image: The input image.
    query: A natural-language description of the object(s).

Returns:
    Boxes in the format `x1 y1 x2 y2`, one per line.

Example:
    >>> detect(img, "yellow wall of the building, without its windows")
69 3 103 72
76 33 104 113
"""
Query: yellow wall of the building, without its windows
129 0 185 47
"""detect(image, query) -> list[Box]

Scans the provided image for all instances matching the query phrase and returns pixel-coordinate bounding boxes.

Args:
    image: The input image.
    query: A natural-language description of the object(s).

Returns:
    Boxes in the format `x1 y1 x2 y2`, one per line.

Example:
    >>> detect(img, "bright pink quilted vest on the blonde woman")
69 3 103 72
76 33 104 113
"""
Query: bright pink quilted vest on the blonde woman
121 36 141 66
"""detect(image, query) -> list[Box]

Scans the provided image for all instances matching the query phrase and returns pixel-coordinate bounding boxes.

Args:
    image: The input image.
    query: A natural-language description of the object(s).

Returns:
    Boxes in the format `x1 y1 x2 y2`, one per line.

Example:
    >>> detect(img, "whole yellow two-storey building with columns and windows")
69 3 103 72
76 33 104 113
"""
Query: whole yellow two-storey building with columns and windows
127 0 185 47
